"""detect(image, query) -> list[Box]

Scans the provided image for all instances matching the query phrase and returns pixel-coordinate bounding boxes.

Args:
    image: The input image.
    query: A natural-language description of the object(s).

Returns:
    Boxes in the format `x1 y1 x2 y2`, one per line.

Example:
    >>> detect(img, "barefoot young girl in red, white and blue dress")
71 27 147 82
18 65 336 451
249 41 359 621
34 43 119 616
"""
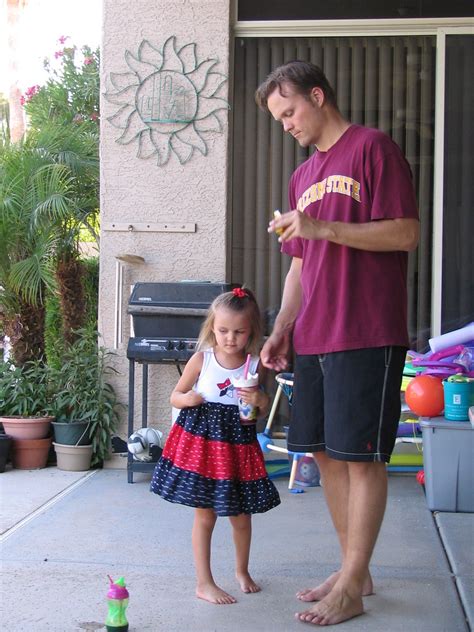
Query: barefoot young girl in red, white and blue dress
151 288 280 604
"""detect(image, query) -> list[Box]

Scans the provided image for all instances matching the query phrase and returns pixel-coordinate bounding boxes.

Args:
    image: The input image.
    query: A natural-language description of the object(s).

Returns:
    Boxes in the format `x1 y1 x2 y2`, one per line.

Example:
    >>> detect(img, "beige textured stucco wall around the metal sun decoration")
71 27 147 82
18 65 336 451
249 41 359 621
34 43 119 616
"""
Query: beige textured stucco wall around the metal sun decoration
99 0 230 438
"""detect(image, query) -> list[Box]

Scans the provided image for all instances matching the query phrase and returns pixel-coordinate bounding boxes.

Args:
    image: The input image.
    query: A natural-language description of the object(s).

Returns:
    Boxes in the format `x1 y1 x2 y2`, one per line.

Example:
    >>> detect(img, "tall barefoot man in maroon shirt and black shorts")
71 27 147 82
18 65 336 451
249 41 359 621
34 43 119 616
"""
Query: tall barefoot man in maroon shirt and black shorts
256 61 418 625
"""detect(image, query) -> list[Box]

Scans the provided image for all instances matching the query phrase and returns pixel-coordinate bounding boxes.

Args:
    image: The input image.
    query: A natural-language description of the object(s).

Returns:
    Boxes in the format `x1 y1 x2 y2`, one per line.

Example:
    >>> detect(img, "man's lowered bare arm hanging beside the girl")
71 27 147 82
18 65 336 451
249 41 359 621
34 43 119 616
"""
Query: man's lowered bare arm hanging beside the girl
260 257 302 371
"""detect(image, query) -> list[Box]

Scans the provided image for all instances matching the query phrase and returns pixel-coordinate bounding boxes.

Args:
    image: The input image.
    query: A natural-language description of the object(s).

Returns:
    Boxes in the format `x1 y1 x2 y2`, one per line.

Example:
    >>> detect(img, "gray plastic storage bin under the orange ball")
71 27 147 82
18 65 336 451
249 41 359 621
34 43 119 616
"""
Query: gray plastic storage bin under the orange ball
420 417 474 513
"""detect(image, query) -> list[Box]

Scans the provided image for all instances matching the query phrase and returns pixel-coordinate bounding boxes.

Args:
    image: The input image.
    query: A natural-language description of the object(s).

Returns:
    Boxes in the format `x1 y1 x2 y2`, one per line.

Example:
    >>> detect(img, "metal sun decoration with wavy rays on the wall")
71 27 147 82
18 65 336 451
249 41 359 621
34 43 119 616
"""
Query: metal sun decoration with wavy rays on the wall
104 36 229 167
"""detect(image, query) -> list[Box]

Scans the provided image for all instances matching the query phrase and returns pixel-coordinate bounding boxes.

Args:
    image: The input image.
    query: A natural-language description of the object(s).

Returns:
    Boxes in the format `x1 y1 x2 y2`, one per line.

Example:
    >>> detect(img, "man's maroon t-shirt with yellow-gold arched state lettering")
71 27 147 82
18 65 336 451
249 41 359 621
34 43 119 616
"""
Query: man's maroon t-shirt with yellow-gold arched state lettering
282 125 418 355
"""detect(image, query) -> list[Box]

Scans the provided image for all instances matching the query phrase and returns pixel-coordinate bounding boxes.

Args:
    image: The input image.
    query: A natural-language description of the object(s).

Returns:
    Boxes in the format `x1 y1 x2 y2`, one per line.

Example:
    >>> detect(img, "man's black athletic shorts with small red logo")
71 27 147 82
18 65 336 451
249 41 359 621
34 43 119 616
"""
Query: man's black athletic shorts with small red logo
288 347 407 463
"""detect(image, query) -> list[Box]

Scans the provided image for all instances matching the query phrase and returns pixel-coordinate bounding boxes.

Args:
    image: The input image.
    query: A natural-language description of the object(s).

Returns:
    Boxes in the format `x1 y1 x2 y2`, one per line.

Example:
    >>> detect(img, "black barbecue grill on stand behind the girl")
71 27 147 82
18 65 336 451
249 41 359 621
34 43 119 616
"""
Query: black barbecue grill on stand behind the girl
127 281 239 483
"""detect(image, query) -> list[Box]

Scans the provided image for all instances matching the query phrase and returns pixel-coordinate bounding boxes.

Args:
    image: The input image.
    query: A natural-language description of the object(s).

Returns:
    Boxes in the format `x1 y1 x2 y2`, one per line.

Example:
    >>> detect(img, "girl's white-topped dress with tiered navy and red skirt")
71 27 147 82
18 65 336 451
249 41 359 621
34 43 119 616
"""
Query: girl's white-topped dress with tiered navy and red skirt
150 349 280 516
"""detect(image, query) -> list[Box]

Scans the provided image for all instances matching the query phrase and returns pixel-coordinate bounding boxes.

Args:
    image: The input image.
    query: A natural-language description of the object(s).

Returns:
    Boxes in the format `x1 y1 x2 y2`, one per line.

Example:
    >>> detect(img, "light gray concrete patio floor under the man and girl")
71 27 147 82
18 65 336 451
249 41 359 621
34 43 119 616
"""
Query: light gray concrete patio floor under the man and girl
0 467 474 632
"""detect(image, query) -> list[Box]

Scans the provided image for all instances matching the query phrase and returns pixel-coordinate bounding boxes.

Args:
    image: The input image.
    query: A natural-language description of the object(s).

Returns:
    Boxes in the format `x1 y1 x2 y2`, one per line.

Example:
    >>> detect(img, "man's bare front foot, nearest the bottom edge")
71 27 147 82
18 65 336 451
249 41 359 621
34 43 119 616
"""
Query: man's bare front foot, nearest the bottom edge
295 586 364 625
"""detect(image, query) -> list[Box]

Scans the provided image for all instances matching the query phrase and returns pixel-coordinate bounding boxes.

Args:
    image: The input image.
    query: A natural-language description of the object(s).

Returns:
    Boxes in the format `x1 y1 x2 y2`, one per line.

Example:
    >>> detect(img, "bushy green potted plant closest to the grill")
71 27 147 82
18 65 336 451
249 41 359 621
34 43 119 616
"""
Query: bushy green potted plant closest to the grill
49 329 119 465
